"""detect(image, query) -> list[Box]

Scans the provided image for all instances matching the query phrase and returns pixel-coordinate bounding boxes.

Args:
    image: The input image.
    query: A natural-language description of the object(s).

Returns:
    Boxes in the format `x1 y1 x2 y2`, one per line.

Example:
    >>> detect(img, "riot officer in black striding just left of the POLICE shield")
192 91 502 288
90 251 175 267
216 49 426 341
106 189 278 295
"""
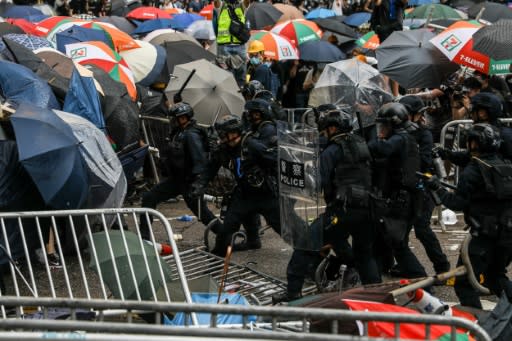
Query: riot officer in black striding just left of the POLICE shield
212 99 281 256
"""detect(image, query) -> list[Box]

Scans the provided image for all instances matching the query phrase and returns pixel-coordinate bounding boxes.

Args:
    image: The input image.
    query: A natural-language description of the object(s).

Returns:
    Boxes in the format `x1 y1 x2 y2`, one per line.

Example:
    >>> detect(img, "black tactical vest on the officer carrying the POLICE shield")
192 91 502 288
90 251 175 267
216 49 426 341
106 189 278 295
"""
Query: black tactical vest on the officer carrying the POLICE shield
333 134 372 207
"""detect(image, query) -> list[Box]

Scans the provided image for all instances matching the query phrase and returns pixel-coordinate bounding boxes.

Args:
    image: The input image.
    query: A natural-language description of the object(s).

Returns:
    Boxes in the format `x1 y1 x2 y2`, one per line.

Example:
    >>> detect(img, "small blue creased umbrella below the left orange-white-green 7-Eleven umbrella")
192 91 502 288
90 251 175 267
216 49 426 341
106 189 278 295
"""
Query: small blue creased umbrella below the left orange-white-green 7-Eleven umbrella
62 69 105 129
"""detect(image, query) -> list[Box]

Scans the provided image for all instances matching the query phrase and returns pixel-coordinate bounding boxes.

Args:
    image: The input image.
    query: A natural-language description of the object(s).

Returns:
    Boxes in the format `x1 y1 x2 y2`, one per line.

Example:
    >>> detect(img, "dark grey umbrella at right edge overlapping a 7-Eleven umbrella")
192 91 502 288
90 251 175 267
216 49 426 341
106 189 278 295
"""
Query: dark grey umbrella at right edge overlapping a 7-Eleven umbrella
473 20 512 60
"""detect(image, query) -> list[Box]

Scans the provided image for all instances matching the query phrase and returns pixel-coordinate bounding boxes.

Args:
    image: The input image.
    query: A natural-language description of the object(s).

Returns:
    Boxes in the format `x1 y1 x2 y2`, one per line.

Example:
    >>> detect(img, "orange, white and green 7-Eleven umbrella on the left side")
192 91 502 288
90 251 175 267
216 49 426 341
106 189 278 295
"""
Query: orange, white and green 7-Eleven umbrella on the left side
66 41 137 100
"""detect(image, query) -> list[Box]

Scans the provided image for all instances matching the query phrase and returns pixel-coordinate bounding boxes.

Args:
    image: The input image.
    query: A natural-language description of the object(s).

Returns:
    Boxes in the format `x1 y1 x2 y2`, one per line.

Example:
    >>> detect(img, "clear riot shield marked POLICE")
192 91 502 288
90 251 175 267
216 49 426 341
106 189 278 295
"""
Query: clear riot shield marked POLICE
277 121 323 250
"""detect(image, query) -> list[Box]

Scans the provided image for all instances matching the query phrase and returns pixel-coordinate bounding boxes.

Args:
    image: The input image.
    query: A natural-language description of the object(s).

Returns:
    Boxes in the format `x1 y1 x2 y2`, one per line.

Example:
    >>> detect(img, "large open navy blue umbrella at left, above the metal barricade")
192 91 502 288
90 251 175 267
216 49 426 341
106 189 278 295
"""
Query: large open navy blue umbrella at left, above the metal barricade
11 103 89 209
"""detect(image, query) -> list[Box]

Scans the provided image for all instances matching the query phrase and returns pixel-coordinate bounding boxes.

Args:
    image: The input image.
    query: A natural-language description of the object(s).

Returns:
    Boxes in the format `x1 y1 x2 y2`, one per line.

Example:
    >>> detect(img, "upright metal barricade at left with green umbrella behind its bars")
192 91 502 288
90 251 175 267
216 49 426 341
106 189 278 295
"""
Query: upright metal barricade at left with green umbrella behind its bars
0 208 196 324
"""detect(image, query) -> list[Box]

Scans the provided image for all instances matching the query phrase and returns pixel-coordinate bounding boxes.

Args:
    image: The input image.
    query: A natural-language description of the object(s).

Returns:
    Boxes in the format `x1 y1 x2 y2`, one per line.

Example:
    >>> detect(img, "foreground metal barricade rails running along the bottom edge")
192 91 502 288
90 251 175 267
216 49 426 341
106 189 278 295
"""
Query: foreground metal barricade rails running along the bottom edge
0 296 491 341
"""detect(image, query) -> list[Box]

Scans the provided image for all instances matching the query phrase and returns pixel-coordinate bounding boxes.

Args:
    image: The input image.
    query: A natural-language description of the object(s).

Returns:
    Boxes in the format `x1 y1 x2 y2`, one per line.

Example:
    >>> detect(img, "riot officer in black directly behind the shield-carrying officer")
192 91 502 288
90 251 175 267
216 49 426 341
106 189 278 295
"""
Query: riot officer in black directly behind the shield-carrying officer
368 103 426 278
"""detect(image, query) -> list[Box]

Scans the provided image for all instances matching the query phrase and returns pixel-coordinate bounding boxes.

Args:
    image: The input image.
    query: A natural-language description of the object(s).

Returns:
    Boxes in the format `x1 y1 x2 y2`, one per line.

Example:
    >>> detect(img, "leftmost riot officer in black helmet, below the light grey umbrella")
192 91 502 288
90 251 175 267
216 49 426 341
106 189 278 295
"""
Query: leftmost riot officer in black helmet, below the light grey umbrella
141 102 215 239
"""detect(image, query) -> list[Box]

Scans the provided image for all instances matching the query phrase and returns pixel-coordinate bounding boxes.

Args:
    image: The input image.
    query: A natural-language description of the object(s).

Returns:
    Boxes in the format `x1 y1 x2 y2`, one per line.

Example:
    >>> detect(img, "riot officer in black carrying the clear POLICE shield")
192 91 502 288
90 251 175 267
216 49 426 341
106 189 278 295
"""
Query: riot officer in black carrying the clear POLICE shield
273 110 381 303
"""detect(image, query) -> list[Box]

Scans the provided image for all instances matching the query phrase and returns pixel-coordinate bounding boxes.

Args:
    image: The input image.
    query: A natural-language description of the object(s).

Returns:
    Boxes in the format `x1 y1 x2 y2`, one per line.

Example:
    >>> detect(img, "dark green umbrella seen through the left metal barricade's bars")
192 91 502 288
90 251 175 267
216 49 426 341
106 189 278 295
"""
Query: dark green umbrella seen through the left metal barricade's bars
89 230 171 300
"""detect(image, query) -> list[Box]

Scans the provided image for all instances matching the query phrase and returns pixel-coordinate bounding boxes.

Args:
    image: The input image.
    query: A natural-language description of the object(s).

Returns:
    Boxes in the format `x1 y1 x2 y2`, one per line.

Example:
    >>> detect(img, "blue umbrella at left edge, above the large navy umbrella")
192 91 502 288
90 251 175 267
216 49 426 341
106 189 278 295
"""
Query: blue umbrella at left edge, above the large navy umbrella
0 60 60 109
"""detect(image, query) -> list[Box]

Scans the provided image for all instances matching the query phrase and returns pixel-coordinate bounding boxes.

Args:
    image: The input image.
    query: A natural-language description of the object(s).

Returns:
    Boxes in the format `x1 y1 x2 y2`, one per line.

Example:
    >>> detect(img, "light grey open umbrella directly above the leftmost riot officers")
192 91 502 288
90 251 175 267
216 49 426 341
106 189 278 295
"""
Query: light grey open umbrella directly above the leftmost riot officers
165 60 244 125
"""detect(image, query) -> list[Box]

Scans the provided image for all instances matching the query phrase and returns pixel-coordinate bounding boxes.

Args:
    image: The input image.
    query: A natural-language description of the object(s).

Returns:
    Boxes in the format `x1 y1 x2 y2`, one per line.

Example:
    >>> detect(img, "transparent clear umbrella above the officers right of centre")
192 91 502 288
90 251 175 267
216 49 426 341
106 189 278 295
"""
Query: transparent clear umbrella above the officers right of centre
308 58 393 127
